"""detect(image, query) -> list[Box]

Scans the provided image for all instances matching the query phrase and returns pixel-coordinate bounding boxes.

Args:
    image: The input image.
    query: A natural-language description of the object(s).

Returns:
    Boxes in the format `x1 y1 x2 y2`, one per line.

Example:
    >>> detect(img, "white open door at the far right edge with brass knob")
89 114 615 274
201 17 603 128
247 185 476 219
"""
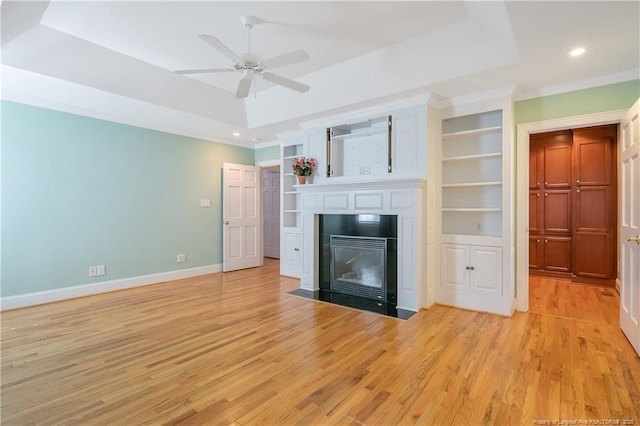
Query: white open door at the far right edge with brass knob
620 100 640 355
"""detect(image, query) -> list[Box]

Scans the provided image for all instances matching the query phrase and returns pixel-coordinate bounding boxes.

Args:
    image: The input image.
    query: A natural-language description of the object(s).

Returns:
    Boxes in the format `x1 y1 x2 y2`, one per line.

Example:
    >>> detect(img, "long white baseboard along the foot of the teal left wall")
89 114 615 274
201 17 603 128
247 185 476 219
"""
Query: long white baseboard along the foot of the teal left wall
0 264 222 311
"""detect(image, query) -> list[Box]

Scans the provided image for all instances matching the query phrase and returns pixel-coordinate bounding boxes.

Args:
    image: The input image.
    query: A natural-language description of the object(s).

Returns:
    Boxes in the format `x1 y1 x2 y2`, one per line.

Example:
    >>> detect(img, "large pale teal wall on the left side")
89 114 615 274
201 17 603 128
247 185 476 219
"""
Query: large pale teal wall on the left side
0 102 254 296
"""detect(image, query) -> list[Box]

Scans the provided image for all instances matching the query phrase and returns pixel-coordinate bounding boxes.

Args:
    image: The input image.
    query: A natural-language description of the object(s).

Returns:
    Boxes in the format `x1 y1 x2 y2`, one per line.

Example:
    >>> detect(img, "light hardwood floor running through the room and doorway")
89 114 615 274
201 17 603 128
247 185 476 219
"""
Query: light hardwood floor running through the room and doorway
1 260 640 425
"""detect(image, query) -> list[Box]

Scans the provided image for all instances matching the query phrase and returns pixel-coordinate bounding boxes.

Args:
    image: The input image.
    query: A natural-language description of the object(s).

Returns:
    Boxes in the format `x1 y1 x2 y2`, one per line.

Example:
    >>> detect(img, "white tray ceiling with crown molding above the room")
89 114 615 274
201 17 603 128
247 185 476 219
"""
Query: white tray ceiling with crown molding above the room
0 0 640 146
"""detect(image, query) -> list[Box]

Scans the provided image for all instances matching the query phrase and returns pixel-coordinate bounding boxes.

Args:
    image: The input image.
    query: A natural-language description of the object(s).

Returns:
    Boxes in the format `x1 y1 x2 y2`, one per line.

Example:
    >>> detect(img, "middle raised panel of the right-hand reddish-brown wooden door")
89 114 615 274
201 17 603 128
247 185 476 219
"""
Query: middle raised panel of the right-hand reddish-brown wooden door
575 186 615 233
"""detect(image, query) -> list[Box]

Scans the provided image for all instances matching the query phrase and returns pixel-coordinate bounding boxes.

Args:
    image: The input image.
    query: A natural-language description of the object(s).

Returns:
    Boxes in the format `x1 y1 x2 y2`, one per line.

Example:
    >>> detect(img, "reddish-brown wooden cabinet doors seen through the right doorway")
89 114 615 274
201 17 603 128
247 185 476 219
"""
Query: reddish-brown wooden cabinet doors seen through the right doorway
529 124 618 287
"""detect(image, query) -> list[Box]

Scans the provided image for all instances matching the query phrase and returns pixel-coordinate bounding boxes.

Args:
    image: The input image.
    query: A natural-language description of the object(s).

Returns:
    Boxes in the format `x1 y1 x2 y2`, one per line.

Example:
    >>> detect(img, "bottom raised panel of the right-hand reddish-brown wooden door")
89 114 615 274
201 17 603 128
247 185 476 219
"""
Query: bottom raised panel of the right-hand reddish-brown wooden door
574 232 613 278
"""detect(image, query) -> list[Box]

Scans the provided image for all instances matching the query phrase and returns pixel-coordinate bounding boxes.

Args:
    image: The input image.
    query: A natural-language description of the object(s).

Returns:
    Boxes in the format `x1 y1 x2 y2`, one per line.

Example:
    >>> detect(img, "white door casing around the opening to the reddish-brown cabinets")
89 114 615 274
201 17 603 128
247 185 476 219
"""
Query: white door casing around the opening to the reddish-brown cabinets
515 109 628 312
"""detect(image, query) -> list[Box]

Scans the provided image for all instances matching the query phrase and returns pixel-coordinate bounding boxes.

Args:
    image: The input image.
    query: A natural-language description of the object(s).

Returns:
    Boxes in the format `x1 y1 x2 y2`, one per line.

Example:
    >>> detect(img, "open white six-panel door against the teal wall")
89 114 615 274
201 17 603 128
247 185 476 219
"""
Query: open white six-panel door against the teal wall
222 163 262 272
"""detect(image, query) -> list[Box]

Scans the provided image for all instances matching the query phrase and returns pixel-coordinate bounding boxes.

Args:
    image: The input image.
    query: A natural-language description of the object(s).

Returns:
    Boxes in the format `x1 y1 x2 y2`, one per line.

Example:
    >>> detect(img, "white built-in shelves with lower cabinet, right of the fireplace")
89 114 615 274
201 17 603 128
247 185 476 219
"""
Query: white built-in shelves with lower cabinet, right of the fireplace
436 102 514 315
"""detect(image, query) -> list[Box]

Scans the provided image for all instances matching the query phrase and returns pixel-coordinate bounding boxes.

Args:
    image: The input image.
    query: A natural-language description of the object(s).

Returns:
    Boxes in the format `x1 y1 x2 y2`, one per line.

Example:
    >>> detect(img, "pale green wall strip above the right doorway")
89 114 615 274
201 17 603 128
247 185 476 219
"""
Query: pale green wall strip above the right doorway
514 80 640 125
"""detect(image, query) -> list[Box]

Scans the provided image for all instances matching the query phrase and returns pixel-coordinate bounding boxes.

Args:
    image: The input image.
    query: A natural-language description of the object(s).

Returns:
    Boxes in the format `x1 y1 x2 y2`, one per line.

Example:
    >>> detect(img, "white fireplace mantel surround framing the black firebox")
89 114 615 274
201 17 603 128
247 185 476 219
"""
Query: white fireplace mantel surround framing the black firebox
296 177 435 311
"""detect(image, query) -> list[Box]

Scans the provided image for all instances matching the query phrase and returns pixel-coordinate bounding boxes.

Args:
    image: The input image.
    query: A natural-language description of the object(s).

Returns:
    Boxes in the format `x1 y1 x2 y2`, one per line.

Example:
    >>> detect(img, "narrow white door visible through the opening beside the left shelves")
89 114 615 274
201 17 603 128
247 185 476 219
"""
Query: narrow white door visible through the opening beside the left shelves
262 170 280 259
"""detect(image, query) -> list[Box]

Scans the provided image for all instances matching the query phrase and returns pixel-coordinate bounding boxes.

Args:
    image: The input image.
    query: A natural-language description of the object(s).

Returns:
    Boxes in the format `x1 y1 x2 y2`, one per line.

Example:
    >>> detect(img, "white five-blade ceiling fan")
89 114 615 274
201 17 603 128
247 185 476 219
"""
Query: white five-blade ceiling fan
175 16 311 98
